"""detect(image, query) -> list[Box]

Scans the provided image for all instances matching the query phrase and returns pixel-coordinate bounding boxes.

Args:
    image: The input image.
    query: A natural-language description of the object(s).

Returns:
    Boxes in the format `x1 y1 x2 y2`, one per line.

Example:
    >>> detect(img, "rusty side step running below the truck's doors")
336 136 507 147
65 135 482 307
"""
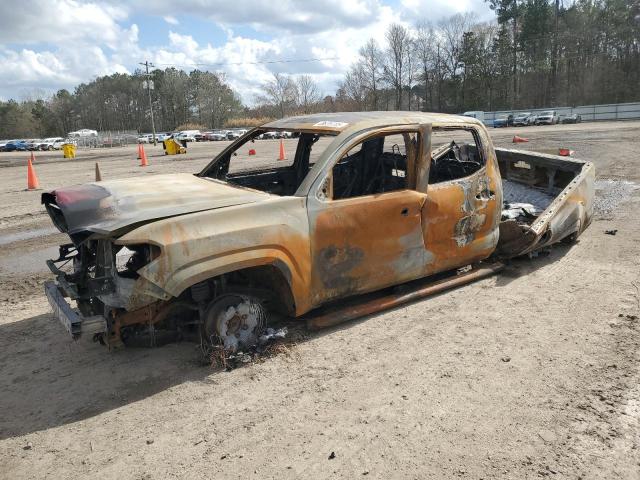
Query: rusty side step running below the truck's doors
307 262 504 330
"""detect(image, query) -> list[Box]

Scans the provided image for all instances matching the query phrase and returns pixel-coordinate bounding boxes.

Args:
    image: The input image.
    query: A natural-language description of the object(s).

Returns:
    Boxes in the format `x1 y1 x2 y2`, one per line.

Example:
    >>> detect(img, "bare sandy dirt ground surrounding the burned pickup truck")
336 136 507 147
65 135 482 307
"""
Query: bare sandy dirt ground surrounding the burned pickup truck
0 122 640 480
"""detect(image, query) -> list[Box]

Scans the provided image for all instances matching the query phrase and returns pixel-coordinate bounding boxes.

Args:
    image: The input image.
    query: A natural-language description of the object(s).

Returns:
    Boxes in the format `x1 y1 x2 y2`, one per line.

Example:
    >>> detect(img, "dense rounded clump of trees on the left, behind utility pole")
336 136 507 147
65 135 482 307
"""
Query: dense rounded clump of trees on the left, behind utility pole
0 68 244 138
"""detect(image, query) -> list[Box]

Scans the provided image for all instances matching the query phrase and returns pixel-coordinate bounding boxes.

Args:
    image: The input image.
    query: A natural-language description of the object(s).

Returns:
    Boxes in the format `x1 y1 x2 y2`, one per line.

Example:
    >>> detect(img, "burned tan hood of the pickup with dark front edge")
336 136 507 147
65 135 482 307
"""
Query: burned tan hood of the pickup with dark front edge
42 173 269 235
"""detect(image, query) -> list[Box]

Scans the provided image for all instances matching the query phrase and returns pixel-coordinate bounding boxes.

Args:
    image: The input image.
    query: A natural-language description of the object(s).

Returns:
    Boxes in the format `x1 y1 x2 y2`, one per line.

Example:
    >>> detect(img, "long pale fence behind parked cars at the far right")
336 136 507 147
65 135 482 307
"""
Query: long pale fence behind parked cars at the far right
484 102 640 125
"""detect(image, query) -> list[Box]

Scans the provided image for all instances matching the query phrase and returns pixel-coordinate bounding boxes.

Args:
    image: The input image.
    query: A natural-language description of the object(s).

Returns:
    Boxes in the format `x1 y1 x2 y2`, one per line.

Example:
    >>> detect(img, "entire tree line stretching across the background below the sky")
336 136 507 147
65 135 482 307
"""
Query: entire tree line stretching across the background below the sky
0 0 640 138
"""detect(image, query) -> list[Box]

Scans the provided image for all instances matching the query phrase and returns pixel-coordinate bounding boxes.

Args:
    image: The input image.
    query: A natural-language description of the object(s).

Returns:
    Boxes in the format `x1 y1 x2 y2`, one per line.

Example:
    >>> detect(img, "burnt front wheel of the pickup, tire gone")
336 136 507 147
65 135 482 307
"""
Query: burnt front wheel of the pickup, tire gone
204 293 267 351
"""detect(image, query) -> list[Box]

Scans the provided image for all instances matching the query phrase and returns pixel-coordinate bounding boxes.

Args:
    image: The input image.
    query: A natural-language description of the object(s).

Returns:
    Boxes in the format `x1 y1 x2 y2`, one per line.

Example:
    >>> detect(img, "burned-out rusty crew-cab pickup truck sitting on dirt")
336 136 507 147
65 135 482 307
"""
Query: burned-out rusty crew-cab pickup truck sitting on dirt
42 112 594 350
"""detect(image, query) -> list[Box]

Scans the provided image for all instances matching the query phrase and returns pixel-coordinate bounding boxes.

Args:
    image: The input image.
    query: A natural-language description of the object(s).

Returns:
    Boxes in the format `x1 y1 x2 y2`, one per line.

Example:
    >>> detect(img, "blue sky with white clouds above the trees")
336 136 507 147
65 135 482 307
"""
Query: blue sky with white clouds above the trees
0 0 493 104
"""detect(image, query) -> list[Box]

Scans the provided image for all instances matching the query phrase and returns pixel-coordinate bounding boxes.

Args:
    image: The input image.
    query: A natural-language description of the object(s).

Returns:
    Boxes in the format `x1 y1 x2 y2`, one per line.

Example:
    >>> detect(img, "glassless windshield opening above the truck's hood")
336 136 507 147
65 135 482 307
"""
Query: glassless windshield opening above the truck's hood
200 129 334 196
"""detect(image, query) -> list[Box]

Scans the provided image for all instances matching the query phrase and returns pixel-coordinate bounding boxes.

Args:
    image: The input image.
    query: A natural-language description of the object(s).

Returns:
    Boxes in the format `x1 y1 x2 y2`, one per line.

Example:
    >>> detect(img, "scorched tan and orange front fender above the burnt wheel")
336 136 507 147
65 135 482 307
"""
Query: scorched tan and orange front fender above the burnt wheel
116 197 311 315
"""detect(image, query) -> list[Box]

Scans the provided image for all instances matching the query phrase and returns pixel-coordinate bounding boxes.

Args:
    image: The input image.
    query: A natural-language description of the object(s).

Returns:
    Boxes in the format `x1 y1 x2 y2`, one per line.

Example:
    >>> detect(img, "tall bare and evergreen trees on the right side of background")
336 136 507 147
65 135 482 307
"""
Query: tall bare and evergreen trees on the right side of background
334 0 640 112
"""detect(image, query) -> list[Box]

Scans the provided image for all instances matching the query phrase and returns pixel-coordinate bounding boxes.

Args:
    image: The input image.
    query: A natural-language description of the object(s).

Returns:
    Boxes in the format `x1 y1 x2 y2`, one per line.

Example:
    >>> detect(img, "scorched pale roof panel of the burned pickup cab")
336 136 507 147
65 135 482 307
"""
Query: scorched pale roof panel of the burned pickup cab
262 111 479 133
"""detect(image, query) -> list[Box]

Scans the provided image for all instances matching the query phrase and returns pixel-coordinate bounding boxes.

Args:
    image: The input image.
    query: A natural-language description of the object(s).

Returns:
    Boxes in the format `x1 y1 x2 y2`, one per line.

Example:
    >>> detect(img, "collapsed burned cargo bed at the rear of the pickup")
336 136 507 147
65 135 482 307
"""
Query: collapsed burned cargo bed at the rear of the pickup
496 148 595 258
